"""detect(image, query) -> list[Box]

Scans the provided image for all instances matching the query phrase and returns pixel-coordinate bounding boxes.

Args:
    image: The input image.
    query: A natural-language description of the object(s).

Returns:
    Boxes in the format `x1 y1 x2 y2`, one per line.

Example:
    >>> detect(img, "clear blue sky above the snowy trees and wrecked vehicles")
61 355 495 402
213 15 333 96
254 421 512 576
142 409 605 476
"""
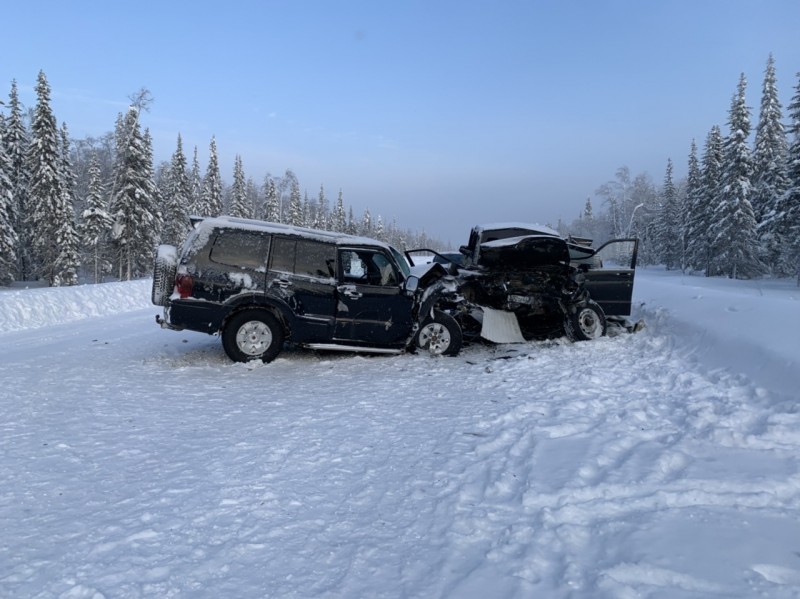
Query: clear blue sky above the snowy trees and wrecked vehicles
0 0 800 244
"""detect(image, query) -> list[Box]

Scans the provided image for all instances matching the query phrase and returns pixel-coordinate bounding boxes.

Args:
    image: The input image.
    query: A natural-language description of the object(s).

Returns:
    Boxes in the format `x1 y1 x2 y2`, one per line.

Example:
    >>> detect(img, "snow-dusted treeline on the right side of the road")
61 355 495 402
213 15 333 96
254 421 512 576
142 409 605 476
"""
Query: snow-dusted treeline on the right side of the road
559 55 800 278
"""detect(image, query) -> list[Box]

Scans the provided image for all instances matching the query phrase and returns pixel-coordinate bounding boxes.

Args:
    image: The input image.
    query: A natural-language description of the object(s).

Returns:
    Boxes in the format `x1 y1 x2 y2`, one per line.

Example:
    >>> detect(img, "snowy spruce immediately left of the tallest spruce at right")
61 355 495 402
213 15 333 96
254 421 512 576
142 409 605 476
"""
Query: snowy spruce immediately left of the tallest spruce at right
714 73 762 279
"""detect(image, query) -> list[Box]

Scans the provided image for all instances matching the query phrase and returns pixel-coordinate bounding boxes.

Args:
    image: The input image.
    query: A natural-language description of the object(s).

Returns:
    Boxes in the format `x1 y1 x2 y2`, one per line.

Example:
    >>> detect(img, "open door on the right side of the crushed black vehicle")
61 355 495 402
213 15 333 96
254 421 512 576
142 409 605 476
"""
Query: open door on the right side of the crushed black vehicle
578 239 639 316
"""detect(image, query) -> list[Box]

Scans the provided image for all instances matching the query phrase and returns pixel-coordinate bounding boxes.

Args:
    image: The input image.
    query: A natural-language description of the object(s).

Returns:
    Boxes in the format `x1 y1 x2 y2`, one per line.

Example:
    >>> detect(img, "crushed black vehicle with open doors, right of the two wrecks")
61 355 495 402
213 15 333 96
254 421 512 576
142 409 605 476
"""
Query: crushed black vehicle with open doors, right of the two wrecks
410 223 638 342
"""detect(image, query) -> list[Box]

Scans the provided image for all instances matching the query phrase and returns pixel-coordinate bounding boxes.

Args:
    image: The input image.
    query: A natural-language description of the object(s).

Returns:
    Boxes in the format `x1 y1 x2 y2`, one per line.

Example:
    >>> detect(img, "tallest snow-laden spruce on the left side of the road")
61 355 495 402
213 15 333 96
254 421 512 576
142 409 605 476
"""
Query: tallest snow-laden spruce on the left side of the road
27 71 63 285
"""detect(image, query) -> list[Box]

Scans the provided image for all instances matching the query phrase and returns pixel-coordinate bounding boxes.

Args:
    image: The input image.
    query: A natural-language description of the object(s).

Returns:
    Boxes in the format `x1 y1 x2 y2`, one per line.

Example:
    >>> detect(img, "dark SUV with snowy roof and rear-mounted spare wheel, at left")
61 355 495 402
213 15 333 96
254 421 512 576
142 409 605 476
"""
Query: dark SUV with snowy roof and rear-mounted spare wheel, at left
152 217 462 362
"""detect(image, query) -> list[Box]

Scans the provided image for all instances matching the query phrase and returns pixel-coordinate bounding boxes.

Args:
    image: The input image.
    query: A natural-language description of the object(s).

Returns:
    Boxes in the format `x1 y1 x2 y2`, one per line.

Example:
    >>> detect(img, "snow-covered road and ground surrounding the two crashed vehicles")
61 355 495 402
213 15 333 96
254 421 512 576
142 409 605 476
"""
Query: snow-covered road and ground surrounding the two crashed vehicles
0 270 800 599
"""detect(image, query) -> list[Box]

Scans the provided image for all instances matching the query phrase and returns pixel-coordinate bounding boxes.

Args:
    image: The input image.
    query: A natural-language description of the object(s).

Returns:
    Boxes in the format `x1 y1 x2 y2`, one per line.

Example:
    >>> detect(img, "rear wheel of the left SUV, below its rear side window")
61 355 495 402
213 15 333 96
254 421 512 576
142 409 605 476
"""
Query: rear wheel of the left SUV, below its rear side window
222 309 284 362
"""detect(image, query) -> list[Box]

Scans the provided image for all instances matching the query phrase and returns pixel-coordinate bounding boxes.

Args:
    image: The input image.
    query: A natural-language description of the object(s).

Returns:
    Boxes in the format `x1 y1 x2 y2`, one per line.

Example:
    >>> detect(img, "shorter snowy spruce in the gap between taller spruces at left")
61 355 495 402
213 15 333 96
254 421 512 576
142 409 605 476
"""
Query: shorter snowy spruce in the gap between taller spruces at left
79 153 114 283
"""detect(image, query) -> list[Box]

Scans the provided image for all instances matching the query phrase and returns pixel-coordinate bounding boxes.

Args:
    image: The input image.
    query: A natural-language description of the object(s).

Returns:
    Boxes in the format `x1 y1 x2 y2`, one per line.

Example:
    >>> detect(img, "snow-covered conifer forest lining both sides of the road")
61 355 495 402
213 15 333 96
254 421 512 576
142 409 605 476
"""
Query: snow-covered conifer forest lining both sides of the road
0 56 800 286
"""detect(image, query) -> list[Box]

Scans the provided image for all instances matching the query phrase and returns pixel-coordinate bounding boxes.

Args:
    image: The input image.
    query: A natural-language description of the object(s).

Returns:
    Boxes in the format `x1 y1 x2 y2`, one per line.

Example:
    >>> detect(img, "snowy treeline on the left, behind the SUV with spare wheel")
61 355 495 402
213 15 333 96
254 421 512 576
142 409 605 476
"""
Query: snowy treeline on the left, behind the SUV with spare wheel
0 72 441 286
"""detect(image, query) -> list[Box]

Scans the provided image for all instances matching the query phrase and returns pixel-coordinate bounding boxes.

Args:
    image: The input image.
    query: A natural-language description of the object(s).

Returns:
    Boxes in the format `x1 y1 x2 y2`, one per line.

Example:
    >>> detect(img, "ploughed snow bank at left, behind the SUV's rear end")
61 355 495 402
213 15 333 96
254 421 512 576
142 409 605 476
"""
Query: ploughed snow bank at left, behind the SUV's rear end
0 279 152 333
